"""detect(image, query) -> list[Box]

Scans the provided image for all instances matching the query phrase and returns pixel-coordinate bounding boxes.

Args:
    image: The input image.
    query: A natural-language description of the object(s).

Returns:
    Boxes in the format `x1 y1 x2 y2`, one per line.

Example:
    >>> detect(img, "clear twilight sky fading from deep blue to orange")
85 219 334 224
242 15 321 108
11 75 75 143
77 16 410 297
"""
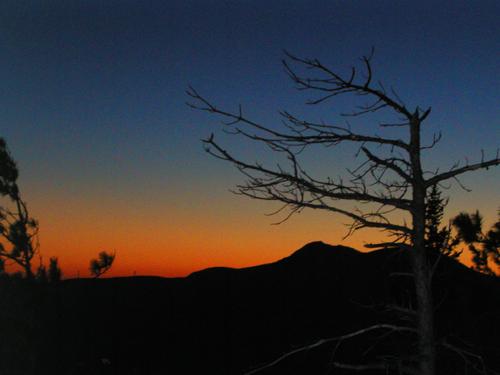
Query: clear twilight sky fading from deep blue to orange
0 0 500 277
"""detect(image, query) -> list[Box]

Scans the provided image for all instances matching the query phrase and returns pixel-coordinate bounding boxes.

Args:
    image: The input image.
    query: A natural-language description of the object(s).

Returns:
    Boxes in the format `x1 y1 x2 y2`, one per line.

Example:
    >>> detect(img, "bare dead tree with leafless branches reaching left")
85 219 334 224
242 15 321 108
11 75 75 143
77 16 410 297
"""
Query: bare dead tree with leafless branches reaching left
187 53 500 375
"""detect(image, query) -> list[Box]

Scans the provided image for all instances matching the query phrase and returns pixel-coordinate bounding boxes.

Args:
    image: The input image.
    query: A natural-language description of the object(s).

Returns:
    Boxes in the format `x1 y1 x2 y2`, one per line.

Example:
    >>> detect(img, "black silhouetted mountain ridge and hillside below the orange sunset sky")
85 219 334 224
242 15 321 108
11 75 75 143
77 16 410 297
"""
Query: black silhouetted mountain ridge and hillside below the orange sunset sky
0 242 500 375
